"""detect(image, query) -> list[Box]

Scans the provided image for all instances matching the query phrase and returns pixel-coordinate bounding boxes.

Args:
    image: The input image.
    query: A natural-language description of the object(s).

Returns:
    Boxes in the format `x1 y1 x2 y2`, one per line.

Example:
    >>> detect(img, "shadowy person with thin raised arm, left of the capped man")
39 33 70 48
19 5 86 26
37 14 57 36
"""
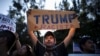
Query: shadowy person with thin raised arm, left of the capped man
12 34 33 56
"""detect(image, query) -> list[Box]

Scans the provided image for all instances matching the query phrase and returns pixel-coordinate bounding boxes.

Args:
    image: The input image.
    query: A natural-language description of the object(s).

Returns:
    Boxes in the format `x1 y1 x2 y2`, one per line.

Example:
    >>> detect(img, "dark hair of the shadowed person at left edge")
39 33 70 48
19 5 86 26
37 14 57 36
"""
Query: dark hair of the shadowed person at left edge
0 30 15 49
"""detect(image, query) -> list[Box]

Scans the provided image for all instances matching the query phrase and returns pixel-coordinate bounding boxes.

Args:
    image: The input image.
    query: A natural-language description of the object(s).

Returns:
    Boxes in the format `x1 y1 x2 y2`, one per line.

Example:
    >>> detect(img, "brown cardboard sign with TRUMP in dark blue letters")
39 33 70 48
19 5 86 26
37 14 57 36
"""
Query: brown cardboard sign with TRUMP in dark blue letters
27 10 79 30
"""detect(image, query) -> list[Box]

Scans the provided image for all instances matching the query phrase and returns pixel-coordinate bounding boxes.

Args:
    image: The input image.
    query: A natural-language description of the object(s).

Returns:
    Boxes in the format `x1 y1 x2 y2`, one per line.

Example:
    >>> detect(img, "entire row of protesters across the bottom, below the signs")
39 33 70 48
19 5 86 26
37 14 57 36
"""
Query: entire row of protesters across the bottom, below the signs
0 28 98 56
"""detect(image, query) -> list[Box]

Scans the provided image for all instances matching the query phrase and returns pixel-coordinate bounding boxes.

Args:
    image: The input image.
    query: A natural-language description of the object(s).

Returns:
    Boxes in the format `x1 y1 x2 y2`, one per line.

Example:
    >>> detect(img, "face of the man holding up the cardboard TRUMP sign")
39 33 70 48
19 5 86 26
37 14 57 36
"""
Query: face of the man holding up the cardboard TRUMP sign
44 35 56 47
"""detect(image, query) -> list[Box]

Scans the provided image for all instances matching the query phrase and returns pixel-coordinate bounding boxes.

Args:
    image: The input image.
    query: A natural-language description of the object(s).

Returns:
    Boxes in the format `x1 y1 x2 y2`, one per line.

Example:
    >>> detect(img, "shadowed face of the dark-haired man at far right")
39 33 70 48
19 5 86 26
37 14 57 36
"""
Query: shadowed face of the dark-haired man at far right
82 40 95 53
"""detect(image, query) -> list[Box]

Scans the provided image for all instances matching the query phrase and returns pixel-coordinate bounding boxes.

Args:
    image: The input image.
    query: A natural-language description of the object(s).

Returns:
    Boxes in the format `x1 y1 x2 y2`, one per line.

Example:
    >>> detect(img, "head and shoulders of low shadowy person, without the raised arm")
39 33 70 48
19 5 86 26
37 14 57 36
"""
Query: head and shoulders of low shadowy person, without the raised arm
12 44 33 56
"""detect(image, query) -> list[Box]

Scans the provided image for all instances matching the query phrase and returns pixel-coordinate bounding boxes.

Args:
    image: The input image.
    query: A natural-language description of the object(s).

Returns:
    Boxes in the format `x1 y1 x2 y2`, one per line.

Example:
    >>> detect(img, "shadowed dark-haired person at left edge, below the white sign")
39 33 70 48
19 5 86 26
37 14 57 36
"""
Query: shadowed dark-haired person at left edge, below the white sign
0 30 16 56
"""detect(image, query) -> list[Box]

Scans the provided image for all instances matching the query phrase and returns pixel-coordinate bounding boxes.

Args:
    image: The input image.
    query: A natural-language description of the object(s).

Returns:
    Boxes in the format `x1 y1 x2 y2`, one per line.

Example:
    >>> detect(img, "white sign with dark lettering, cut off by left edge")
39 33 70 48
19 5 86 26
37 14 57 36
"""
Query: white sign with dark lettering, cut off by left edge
0 14 16 33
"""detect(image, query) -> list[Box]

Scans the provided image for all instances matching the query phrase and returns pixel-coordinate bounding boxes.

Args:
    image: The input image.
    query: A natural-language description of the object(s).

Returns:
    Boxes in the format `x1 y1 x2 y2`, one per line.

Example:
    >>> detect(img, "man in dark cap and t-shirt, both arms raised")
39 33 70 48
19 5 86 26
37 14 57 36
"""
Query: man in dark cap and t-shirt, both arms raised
29 27 75 56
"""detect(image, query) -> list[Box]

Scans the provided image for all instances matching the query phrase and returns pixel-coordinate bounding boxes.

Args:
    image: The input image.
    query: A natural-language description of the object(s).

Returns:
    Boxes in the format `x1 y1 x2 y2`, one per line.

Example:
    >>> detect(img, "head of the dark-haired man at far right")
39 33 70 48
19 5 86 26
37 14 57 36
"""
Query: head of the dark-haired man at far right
79 37 95 53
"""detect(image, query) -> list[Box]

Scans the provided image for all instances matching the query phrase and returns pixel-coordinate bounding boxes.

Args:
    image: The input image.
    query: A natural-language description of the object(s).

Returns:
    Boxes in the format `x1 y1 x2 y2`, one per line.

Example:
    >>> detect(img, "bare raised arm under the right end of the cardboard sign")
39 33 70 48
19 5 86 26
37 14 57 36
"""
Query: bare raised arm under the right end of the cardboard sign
64 27 75 47
